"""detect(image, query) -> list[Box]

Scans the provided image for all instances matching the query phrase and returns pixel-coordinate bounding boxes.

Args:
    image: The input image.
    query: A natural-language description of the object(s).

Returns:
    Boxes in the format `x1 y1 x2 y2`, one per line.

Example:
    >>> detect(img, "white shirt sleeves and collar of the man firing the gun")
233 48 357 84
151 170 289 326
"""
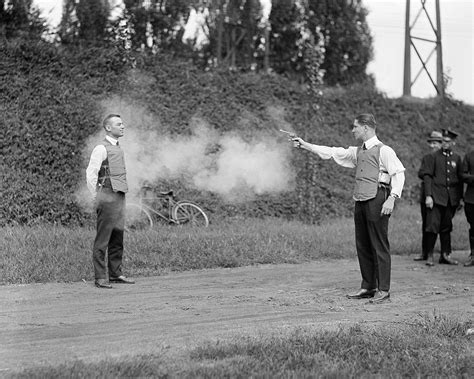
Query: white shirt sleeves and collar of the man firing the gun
307 136 405 197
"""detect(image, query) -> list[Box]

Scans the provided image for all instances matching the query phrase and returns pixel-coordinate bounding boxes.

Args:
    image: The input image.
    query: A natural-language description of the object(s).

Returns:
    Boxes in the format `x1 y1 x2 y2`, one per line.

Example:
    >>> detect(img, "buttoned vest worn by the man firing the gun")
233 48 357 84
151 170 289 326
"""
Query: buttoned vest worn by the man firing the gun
353 144 390 201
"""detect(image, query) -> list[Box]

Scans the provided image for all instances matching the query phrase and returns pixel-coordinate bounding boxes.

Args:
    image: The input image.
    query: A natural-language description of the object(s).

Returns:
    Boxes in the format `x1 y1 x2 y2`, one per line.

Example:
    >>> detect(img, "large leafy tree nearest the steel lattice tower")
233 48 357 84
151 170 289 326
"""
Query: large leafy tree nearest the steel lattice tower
270 0 372 85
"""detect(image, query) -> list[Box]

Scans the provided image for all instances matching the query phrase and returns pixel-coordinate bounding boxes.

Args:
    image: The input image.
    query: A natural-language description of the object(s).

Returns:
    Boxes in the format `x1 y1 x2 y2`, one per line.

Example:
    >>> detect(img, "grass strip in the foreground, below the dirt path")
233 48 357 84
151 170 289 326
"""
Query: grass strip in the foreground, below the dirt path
12 314 474 378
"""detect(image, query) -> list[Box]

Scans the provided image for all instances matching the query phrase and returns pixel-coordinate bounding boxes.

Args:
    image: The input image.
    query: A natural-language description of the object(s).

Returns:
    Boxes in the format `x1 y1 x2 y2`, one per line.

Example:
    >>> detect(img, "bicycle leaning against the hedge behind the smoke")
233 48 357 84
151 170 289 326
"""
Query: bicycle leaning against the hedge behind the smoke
125 186 209 231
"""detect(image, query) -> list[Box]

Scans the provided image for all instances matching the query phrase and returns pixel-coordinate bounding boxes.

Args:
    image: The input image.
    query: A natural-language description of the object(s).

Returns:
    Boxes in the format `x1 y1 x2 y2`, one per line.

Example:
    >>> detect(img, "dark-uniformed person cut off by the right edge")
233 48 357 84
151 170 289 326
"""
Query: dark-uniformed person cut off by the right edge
462 150 474 267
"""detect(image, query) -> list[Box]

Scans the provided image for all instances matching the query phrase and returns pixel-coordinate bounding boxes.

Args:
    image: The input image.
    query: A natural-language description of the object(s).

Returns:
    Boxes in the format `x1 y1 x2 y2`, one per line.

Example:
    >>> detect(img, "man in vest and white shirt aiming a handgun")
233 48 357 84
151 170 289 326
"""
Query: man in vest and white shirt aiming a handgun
292 113 405 303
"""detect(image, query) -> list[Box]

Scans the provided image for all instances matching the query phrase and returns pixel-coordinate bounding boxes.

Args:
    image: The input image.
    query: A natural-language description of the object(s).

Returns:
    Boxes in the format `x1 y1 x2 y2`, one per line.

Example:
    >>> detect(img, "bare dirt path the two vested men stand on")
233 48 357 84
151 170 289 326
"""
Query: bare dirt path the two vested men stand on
0 252 474 377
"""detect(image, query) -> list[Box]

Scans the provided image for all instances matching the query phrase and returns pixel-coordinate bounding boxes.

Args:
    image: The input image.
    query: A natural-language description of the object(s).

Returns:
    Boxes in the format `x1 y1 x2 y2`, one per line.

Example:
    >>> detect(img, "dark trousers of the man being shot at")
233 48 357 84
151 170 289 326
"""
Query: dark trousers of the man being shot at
92 189 125 279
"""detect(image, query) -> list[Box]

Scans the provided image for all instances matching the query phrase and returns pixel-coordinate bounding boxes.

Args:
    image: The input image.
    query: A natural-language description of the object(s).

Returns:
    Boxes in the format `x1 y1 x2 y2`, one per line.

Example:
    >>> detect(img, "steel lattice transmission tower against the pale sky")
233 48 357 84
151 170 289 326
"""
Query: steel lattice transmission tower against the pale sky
403 0 444 97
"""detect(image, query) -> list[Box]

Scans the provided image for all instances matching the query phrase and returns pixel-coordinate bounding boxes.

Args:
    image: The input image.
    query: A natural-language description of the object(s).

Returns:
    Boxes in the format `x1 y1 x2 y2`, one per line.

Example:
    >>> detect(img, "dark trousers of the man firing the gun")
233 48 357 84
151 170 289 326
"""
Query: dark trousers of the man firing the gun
354 187 391 291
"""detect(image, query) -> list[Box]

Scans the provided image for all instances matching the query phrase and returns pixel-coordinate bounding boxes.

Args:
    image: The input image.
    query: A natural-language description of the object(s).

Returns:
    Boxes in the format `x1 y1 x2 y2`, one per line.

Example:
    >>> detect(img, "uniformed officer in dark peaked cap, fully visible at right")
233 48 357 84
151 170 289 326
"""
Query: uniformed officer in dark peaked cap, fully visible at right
419 129 463 266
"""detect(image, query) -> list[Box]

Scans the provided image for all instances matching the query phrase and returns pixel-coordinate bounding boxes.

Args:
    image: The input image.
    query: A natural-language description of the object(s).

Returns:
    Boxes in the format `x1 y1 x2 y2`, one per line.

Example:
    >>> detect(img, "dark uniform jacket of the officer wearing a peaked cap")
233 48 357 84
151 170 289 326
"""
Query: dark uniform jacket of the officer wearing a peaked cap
418 149 463 207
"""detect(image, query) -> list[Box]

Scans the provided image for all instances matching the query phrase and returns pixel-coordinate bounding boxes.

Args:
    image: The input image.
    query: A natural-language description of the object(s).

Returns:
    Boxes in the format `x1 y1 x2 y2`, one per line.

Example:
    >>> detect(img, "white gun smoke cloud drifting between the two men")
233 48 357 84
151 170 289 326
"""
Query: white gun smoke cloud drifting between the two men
79 99 295 202
